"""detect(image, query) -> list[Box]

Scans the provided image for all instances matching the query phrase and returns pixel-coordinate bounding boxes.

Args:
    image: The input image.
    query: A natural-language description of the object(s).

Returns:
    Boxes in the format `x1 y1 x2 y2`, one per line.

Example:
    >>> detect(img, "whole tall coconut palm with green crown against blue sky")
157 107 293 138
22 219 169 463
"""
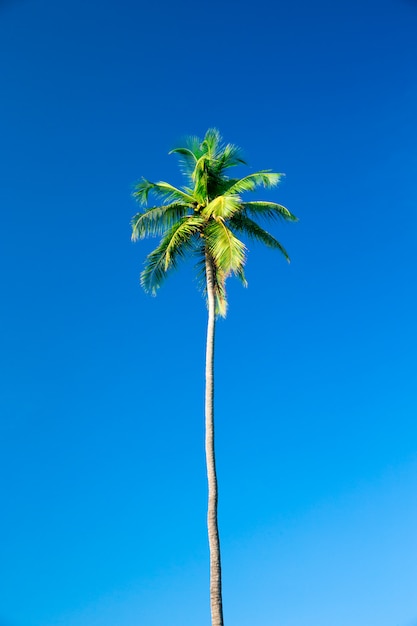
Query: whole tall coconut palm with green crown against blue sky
132 129 297 626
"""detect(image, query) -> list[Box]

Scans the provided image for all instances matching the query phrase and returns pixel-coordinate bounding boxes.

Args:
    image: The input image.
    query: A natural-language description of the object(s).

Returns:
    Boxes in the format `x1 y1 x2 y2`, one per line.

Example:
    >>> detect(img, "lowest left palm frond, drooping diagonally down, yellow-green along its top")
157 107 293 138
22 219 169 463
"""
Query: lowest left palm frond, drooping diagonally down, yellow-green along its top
140 216 204 295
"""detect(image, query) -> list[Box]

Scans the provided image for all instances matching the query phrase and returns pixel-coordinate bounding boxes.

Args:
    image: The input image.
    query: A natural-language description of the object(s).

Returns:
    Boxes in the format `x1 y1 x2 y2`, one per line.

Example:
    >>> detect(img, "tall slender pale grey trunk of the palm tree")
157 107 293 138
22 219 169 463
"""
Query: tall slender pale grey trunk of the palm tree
205 252 223 626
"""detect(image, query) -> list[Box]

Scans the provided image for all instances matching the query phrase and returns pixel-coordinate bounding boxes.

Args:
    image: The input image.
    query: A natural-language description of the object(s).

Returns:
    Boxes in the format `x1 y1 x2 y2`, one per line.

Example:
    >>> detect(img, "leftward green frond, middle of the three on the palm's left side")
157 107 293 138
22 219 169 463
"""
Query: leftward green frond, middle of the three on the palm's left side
131 203 189 241
